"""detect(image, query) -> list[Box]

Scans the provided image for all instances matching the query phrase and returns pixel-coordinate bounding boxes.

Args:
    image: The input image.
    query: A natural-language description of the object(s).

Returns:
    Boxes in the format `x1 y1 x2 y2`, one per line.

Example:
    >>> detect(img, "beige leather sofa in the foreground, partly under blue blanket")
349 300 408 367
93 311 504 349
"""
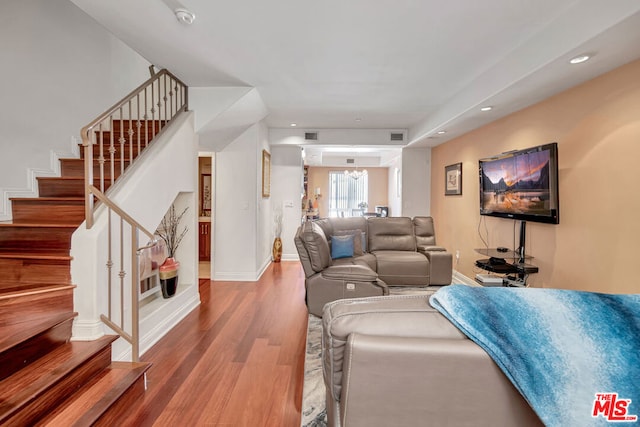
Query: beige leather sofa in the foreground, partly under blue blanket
322 295 543 427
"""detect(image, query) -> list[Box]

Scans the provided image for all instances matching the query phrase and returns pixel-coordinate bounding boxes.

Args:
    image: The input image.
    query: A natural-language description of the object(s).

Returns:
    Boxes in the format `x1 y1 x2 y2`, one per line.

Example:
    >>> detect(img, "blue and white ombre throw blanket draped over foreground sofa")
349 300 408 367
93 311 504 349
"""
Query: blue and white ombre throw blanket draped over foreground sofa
430 285 640 427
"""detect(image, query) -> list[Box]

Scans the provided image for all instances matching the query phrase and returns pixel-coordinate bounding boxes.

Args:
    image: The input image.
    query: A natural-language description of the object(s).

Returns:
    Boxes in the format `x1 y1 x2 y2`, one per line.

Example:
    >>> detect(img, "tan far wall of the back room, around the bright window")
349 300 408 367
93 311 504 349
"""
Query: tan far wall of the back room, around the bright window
308 166 389 218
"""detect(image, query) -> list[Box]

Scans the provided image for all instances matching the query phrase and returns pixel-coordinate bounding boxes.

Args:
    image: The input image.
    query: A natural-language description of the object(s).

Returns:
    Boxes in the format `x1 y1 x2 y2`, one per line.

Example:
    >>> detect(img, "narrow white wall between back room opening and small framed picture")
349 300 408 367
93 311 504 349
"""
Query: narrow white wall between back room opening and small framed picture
402 148 432 221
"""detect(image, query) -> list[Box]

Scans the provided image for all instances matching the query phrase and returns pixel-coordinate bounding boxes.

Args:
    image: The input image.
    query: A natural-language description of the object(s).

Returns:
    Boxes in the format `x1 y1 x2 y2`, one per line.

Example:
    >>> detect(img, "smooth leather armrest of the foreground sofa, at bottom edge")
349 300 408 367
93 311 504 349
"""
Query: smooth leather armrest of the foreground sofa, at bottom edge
338 333 542 426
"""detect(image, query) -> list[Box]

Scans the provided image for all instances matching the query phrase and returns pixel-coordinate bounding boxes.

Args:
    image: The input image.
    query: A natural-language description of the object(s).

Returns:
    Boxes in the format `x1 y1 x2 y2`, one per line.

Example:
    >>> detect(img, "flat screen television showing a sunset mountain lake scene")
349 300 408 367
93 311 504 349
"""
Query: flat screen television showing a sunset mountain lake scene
479 142 560 224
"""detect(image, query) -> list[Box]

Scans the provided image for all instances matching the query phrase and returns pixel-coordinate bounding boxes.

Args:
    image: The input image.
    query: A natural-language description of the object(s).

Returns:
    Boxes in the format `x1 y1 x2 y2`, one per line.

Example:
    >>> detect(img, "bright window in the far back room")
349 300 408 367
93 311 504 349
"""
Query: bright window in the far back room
329 171 369 217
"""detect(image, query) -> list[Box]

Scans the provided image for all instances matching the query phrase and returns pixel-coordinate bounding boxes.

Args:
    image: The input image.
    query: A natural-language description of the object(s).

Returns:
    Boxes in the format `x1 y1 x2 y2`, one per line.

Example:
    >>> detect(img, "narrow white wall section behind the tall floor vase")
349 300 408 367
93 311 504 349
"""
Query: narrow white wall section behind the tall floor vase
271 146 303 260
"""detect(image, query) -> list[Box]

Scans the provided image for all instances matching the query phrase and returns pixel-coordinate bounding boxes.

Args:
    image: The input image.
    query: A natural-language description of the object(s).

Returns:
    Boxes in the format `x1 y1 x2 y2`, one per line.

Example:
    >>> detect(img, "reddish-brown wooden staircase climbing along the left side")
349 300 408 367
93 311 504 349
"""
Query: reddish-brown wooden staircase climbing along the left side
0 120 158 426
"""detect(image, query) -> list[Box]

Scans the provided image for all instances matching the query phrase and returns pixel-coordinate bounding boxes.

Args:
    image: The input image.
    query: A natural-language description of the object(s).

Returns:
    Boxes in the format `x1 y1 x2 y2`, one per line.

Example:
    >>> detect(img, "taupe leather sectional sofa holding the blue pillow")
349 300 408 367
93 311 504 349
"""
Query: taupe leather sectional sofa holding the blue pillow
294 217 452 316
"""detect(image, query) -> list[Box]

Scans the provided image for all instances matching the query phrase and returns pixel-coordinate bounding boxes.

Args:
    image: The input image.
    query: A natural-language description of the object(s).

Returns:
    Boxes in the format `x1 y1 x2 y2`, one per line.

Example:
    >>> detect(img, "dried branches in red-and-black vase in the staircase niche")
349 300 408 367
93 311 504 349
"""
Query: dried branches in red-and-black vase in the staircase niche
156 205 188 298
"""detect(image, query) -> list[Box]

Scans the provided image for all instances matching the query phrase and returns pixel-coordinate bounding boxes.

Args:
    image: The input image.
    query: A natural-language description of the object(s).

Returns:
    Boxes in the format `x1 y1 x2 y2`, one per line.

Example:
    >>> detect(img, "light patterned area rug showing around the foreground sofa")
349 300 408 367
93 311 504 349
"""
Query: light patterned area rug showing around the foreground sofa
301 286 441 427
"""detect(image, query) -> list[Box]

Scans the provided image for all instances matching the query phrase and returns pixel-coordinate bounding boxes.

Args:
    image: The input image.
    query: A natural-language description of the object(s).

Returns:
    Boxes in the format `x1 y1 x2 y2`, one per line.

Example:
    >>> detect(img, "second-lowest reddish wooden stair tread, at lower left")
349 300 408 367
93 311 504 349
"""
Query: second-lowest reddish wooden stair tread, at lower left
0 335 117 424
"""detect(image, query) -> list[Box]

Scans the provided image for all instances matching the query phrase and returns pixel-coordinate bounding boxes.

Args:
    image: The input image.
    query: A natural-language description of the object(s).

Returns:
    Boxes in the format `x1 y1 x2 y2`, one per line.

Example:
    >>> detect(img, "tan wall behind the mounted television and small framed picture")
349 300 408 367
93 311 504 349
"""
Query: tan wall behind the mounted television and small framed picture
431 61 640 293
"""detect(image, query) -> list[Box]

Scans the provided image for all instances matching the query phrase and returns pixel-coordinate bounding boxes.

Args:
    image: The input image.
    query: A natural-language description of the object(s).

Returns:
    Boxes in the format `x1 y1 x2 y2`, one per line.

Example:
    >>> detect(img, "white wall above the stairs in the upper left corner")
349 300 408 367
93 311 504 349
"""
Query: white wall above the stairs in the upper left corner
0 0 149 219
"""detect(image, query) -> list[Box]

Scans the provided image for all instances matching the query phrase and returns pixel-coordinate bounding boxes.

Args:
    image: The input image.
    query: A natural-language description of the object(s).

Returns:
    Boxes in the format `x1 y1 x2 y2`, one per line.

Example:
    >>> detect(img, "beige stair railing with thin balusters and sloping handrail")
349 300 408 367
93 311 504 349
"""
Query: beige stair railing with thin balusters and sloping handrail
80 70 189 362
